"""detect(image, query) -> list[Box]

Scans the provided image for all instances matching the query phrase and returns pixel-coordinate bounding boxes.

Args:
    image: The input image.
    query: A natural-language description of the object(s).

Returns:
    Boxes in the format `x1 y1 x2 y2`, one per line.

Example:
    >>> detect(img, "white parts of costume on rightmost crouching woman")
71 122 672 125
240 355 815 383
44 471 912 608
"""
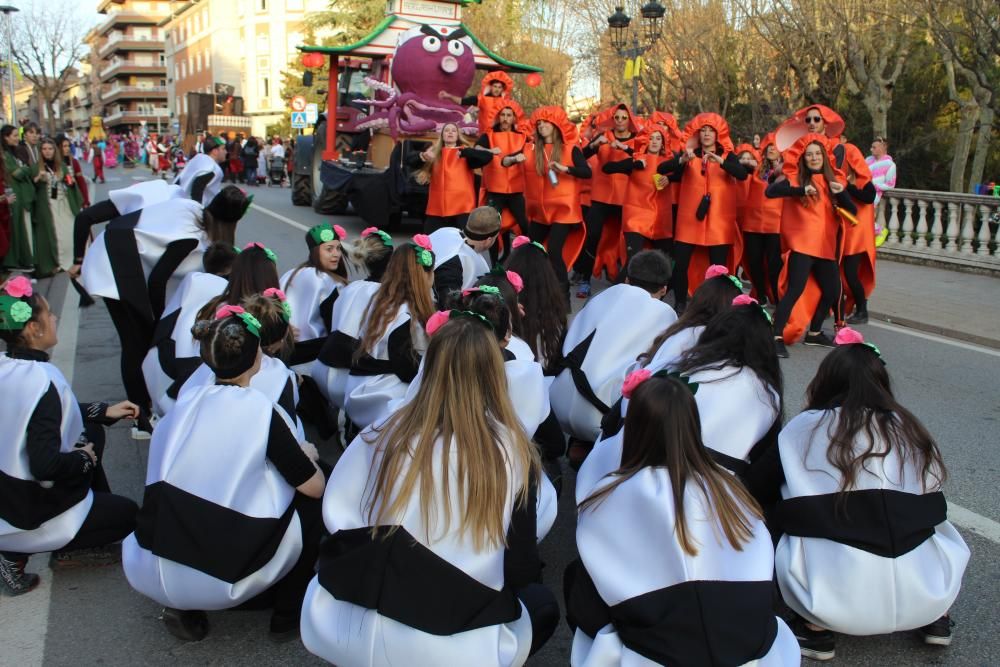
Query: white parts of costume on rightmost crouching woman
775 409 969 635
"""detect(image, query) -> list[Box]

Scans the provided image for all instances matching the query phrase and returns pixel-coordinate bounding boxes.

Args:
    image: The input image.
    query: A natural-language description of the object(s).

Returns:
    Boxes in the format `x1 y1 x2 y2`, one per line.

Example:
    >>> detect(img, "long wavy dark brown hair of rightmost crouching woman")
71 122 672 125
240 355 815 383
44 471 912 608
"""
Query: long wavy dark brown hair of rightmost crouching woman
805 345 947 492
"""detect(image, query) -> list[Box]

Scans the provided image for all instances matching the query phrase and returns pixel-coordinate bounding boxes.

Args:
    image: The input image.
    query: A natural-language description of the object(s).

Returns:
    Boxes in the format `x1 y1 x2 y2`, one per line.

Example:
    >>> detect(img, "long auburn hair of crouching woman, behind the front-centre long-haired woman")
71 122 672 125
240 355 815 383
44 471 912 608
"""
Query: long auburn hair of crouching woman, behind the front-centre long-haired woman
354 243 434 360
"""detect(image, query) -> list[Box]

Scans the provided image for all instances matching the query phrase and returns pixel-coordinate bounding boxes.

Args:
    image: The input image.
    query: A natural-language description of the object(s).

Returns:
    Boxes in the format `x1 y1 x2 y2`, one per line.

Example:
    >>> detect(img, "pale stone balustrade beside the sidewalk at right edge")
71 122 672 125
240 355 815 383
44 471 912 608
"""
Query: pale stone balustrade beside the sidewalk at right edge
876 189 1000 270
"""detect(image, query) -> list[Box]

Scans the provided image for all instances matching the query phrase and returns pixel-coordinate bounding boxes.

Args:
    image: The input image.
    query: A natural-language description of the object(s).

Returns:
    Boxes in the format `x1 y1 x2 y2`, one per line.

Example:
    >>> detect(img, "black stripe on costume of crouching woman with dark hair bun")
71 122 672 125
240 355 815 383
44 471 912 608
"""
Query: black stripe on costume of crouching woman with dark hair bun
135 481 295 584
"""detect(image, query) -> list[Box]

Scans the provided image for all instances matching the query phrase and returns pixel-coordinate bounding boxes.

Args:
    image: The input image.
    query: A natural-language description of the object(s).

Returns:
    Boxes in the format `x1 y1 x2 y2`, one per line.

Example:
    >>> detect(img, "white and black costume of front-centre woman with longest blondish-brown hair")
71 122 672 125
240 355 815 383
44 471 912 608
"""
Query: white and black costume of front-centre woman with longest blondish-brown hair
301 431 556 667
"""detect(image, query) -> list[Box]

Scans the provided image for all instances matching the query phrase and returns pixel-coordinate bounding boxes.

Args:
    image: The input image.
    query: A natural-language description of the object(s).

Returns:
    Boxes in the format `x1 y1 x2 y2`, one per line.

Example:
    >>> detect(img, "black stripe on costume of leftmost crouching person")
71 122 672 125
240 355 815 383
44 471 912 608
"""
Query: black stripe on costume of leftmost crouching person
0 470 91 530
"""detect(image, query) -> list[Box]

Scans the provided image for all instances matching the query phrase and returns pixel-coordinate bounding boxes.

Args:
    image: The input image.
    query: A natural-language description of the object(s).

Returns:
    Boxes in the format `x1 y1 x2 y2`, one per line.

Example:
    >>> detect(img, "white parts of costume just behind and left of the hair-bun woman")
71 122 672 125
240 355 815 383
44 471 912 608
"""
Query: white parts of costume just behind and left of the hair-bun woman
142 271 228 417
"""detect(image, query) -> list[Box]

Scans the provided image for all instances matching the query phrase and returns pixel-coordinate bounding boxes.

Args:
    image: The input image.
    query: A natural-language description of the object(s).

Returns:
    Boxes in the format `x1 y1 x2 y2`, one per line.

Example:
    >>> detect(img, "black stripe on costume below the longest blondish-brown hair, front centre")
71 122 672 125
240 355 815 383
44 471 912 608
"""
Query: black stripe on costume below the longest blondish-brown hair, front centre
319 526 521 636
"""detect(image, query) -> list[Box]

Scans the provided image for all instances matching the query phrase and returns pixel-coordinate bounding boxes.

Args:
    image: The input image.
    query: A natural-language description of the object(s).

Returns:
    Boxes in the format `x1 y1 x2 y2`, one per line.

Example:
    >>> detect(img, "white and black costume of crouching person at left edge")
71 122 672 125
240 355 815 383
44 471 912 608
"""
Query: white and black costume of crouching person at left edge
0 348 137 555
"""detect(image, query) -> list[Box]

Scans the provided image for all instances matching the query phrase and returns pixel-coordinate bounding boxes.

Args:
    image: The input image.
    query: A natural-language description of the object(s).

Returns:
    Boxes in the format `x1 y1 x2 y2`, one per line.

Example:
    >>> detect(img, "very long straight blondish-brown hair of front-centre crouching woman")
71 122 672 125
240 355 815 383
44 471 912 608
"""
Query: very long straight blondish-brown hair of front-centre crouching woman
363 317 541 551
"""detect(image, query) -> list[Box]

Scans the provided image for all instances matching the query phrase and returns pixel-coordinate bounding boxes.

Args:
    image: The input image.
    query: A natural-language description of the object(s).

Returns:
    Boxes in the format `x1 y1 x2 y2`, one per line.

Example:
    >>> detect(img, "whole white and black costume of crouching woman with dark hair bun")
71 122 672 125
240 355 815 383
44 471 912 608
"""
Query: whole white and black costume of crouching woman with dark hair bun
122 384 318 610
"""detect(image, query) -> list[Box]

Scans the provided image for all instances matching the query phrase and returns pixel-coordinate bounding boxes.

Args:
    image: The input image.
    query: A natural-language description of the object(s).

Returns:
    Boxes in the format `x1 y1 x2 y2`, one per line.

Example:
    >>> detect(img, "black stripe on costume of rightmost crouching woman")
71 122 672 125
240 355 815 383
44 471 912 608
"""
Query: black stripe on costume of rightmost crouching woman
774 489 948 558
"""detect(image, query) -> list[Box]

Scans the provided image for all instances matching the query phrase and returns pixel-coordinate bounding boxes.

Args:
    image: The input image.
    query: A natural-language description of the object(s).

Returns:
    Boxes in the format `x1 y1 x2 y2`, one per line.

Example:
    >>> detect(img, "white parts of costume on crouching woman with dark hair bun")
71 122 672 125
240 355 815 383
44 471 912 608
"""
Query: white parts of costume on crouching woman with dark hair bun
122 385 302 610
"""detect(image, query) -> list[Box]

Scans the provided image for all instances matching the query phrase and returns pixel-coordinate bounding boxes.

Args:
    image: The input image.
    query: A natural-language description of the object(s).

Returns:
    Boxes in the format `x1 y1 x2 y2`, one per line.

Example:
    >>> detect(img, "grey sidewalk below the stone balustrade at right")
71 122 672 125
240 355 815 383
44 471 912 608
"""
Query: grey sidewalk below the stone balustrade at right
868 257 1000 348
